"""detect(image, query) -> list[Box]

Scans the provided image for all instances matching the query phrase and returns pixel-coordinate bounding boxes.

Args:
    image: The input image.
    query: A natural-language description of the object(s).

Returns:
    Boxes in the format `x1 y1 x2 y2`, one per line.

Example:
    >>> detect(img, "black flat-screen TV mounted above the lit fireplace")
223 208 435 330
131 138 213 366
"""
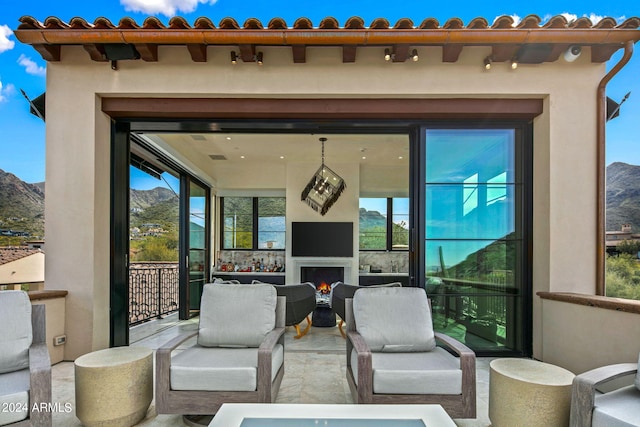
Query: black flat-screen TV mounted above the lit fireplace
291 222 353 257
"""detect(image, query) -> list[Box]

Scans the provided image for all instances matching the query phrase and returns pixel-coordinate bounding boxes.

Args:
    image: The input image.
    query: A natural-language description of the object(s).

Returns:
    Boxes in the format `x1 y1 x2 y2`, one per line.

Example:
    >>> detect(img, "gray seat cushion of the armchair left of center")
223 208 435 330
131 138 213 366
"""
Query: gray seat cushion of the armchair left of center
171 344 284 391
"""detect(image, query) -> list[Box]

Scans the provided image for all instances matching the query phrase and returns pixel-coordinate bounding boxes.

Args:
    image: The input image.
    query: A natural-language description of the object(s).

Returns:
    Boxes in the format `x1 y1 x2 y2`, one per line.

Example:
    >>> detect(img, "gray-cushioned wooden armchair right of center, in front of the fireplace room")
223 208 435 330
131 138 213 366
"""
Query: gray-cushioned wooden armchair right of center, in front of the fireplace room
345 288 476 418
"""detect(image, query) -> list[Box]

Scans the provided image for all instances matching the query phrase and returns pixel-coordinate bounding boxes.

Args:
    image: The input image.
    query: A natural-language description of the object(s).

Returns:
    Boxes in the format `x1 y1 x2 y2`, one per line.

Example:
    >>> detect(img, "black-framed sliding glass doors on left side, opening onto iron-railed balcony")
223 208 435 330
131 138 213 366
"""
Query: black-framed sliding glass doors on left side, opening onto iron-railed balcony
109 122 211 347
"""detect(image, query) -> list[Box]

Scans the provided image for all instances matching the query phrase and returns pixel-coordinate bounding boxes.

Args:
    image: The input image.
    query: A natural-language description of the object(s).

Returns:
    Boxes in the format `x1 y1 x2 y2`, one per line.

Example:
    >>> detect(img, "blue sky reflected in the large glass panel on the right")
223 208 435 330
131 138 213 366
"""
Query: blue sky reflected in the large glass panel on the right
425 129 517 271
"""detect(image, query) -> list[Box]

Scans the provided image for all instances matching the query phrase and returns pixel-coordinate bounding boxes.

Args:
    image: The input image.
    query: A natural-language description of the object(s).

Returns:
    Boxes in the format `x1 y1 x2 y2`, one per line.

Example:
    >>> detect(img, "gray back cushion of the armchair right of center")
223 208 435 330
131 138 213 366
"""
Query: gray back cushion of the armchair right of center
353 287 436 352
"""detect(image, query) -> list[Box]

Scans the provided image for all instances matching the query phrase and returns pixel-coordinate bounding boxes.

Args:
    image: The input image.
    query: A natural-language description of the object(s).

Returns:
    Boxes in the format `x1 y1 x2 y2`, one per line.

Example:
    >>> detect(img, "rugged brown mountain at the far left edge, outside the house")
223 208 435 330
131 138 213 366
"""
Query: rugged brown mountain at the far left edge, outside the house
0 169 44 239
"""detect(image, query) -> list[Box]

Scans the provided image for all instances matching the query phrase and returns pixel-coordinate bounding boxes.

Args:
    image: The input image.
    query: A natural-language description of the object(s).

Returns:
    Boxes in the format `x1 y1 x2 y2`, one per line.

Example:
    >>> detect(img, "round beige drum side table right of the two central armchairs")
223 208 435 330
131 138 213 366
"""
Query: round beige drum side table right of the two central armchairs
489 359 575 427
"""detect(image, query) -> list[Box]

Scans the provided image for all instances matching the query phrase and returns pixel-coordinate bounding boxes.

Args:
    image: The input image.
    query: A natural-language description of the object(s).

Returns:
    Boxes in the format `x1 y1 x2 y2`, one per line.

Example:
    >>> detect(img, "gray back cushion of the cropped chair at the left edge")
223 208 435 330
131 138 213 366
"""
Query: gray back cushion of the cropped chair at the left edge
0 291 33 374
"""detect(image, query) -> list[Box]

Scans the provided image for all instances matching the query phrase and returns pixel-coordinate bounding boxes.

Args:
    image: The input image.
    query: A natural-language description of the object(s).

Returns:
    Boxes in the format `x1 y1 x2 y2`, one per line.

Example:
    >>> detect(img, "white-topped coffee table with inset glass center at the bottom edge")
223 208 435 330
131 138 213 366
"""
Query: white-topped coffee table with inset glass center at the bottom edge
209 403 456 427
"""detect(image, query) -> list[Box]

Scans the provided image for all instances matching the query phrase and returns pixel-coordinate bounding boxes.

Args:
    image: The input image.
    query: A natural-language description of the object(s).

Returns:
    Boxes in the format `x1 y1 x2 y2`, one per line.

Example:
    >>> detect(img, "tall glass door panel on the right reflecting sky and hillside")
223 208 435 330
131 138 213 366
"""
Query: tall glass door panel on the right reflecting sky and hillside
423 126 531 354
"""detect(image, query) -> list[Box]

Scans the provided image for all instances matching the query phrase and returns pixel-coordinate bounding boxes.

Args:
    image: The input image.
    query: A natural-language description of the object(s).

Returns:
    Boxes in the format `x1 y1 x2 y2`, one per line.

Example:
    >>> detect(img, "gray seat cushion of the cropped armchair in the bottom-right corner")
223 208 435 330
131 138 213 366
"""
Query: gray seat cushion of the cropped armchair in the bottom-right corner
591 385 640 427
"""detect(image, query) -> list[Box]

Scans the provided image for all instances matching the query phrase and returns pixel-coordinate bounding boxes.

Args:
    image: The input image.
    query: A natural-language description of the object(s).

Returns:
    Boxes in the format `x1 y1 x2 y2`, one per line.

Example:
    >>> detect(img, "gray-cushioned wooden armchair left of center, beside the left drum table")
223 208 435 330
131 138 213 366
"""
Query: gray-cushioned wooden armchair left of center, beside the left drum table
156 284 285 415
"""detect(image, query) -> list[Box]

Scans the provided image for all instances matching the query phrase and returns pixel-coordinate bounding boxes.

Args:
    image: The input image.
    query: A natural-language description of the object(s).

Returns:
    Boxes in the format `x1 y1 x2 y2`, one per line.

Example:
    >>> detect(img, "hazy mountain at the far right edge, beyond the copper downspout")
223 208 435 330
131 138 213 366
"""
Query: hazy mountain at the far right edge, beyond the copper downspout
606 162 640 233
